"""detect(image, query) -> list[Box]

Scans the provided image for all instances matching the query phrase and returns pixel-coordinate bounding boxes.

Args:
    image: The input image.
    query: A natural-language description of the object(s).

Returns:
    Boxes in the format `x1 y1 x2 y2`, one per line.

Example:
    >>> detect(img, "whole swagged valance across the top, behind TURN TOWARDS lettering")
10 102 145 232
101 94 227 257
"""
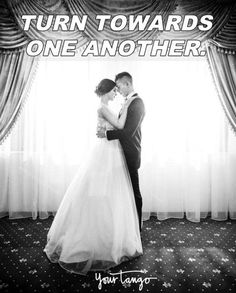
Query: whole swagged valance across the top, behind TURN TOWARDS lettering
0 0 236 50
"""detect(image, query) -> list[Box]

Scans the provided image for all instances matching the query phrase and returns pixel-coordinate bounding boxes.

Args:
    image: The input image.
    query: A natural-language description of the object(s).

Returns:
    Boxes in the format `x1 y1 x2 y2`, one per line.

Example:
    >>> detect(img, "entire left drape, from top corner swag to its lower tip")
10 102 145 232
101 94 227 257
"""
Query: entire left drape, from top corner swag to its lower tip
0 0 37 143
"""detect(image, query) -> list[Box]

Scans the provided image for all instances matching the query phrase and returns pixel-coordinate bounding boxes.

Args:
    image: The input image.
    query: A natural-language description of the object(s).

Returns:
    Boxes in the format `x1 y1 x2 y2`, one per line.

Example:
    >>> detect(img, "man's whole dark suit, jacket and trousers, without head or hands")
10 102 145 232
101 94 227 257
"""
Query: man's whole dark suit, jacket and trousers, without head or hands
106 94 145 231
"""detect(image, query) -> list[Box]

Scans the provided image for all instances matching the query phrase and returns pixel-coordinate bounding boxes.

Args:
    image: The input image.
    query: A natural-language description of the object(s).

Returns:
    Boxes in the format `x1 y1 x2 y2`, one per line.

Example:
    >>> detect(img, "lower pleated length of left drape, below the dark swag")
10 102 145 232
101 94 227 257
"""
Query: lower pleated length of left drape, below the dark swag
0 50 37 142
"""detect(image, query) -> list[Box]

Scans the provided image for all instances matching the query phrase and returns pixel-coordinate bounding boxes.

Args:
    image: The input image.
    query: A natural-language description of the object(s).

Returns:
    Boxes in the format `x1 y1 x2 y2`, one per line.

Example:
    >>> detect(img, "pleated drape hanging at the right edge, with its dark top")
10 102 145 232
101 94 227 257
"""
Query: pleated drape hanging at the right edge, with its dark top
206 3 236 131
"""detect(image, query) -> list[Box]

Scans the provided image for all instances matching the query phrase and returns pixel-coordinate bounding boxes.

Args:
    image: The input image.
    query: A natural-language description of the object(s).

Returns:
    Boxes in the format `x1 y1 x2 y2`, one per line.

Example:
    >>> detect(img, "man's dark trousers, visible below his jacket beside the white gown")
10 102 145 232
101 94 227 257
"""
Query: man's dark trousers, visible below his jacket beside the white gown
128 165 143 232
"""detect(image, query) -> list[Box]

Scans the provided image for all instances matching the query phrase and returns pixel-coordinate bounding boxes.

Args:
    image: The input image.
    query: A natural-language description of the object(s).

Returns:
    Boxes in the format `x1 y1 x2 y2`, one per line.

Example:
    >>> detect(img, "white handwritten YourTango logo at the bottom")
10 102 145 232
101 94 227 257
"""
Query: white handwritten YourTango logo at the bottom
95 270 157 291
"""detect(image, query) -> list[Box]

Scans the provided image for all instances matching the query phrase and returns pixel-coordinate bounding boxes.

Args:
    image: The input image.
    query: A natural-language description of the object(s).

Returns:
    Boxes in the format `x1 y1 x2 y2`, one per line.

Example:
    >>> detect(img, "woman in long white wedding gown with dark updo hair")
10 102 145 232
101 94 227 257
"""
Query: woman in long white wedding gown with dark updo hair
44 79 143 275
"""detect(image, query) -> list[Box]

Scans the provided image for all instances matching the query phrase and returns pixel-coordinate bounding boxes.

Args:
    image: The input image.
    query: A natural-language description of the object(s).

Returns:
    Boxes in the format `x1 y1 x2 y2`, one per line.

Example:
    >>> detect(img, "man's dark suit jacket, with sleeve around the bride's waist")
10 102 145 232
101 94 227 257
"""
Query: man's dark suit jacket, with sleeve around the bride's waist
107 94 145 169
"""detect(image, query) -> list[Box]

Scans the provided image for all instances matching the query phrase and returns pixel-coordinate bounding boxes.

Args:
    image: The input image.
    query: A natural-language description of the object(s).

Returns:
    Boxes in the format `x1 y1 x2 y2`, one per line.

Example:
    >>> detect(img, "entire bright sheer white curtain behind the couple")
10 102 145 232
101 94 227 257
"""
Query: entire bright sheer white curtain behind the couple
0 57 236 221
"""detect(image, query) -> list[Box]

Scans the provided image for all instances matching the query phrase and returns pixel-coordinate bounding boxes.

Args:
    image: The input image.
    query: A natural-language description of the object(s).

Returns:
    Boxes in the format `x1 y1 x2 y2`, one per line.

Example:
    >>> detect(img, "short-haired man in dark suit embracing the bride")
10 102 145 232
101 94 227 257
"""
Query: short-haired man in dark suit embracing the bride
97 72 145 232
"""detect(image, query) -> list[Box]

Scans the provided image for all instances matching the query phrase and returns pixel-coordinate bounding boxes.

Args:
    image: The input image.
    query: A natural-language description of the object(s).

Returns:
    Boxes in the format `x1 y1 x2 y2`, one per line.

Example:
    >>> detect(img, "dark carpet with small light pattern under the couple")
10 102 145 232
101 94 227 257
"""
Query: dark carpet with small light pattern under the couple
0 217 236 293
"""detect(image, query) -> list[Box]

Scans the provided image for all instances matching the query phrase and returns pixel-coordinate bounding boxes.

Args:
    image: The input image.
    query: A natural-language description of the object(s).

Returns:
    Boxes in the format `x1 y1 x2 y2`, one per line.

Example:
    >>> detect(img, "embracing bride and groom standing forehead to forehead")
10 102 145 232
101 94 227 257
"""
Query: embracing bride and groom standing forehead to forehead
44 72 145 274
